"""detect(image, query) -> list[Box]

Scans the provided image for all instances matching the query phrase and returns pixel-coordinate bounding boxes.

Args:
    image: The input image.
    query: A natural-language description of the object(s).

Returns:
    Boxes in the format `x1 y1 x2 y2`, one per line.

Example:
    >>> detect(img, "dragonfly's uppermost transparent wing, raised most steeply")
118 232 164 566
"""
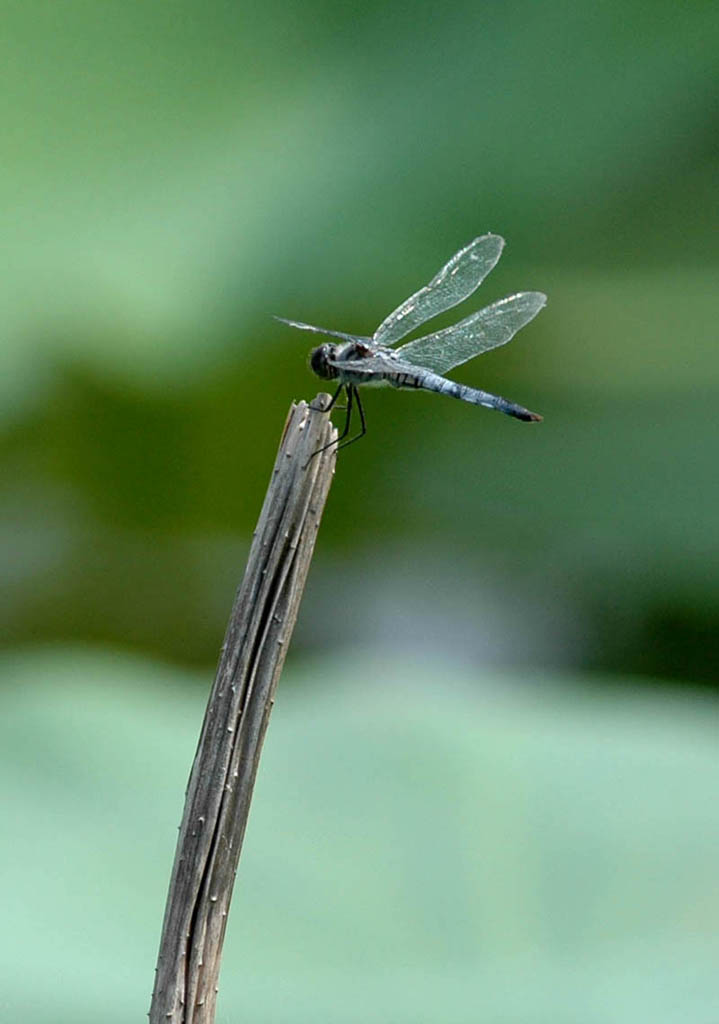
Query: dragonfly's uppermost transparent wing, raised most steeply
372 234 504 345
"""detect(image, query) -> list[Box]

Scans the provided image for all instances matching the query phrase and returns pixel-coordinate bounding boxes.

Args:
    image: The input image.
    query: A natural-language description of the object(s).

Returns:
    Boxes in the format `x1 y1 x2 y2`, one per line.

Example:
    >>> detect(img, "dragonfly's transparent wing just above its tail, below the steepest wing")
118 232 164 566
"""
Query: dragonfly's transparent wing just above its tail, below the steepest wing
395 292 547 374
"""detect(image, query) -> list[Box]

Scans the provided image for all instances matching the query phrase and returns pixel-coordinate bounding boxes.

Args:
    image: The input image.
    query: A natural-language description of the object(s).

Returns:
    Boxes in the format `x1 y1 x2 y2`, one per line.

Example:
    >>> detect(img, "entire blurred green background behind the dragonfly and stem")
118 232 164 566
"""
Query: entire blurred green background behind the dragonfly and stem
0 0 719 1024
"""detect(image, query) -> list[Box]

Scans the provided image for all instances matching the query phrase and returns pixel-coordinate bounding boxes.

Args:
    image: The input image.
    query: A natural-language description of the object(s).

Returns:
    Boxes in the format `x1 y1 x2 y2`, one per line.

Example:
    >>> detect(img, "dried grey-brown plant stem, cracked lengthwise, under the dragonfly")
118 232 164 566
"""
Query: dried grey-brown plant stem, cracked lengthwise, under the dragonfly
150 395 337 1024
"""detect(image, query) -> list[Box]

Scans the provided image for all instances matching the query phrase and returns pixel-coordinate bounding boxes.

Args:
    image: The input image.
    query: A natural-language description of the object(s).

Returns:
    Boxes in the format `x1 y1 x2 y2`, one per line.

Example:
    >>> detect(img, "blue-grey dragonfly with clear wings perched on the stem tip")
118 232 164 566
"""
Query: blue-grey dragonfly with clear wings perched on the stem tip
276 233 547 455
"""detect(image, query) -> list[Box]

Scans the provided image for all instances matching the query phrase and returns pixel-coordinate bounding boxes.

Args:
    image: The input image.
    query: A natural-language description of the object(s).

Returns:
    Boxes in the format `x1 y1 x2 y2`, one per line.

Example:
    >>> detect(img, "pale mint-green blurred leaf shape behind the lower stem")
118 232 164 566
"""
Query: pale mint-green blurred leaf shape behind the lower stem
0 651 719 1024
